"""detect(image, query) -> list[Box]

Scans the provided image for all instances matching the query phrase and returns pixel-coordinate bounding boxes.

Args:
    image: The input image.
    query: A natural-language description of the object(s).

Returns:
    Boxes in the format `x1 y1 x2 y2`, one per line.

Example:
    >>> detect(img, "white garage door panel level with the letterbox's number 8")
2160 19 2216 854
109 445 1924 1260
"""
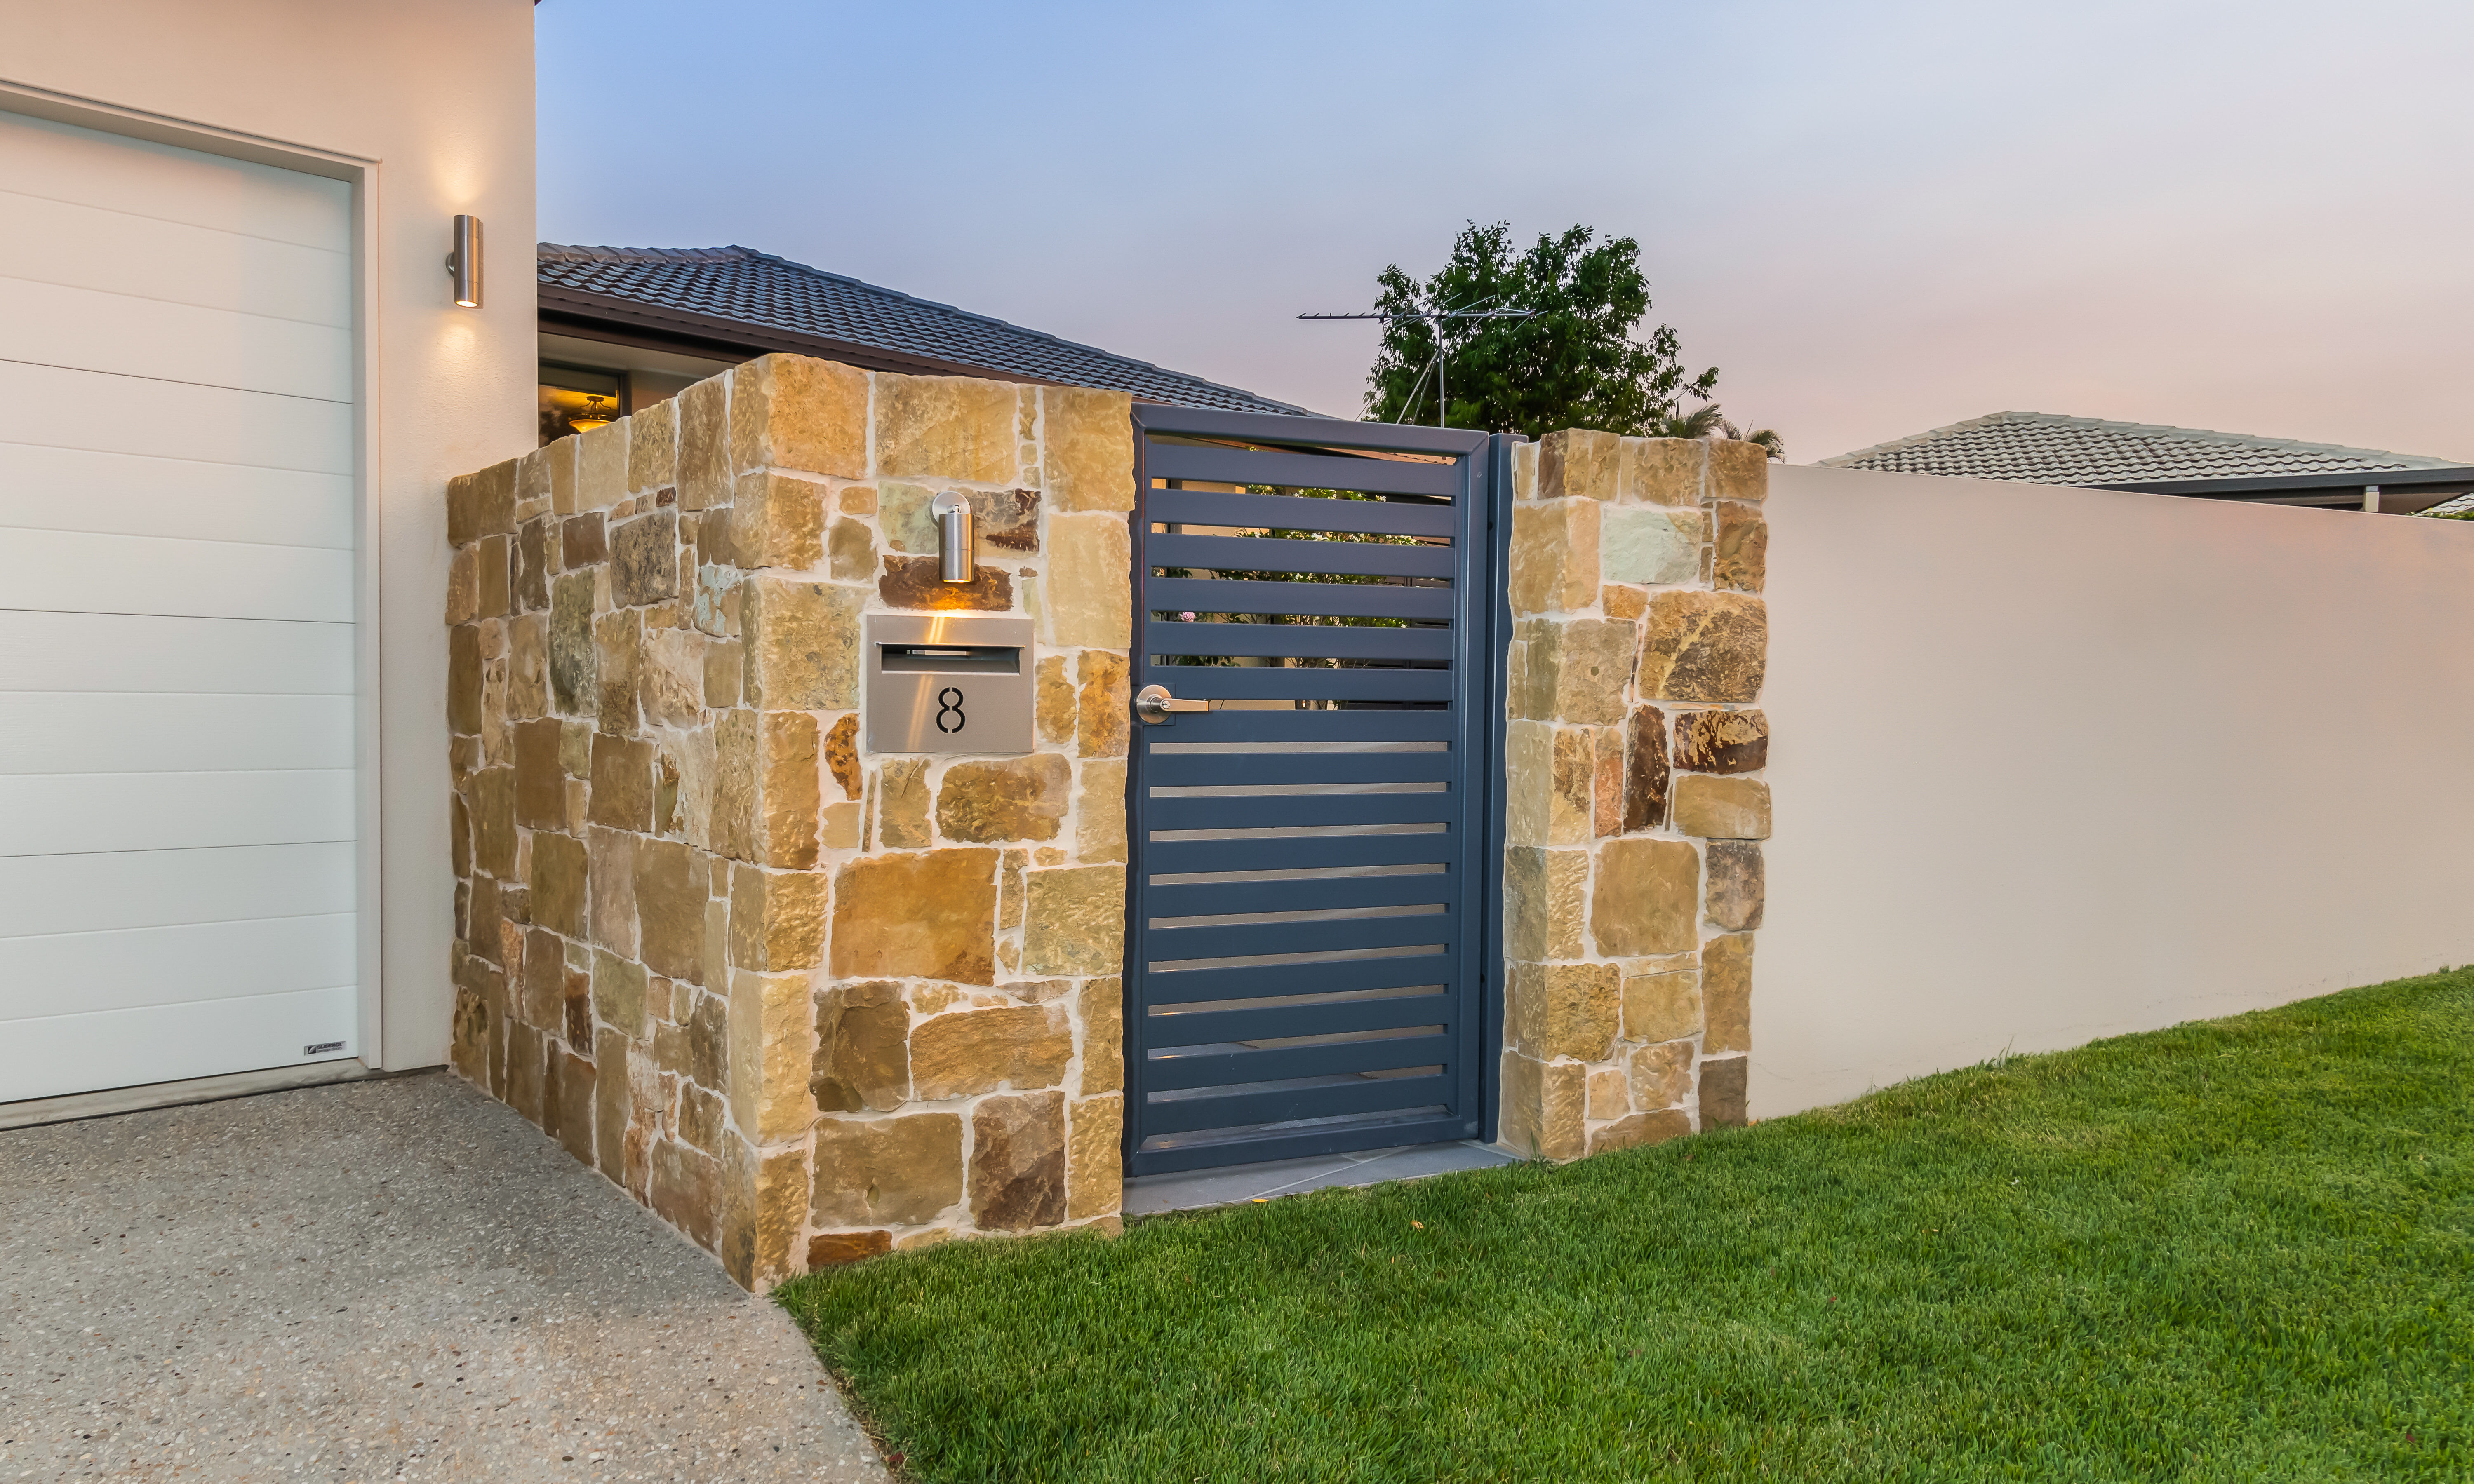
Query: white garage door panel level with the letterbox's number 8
0 690 356 774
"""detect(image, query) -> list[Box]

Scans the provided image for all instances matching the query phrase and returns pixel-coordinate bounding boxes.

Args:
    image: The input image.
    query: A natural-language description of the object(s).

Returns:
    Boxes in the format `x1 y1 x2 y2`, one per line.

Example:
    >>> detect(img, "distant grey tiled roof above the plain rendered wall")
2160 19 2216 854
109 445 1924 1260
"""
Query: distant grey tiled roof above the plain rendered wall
1821 413 2457 485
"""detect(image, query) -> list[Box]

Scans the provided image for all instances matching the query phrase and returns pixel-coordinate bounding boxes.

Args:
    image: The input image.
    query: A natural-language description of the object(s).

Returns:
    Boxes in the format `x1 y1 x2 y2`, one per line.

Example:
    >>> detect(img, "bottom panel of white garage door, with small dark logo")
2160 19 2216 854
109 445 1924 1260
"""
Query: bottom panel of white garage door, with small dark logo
0 987 361 1098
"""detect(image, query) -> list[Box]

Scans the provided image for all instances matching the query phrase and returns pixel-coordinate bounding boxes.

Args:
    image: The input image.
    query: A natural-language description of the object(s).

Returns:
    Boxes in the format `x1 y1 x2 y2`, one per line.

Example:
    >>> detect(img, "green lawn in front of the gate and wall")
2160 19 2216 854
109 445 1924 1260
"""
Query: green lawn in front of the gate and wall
779 972 2474 1484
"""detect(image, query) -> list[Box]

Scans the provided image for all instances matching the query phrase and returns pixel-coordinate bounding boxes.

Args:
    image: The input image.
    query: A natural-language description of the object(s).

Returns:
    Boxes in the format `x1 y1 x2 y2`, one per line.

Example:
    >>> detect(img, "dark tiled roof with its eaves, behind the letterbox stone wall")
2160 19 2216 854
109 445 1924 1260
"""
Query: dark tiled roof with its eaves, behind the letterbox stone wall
539 242 1314 416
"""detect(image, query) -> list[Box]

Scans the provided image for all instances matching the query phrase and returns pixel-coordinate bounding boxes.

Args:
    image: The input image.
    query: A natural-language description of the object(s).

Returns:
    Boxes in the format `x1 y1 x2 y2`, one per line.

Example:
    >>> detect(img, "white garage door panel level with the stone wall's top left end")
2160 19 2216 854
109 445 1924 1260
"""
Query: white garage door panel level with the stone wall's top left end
0 361 351 475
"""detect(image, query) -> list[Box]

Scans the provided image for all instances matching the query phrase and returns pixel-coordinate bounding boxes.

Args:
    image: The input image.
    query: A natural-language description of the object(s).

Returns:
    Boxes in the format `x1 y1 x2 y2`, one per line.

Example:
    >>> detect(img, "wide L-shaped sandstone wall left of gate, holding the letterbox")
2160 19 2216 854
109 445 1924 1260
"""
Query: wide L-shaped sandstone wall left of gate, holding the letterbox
448 356 1133 1286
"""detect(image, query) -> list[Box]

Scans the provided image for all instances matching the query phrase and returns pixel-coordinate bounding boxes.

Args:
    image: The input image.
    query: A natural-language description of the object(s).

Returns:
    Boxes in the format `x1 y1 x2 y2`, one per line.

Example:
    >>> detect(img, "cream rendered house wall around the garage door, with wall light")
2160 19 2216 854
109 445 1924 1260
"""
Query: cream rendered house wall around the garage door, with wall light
0 0 537 1066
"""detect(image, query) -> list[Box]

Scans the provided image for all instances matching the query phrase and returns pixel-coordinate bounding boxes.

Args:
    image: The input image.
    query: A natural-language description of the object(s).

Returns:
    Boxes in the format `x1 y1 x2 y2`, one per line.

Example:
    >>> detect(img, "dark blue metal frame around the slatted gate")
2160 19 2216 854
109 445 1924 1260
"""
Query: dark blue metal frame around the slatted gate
1118 401 1524 1180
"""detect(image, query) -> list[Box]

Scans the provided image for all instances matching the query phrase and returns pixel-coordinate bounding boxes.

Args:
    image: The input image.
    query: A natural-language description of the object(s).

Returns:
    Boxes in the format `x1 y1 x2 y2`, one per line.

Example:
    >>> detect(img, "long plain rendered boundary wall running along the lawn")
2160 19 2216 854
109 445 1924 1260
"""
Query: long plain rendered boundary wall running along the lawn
1752 467 2474 1118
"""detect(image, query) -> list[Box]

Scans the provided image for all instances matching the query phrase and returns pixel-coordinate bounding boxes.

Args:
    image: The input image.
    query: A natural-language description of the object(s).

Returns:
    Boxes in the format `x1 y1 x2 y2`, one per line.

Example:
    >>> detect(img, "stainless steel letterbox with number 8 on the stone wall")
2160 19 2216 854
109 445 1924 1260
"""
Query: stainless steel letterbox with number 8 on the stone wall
866 613 1032 752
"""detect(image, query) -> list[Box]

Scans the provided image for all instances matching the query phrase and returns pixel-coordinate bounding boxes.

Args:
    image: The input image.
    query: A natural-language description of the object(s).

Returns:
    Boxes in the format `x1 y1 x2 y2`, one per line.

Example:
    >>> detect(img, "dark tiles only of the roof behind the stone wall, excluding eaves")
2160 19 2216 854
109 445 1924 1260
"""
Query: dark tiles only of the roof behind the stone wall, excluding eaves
539 242 1306 413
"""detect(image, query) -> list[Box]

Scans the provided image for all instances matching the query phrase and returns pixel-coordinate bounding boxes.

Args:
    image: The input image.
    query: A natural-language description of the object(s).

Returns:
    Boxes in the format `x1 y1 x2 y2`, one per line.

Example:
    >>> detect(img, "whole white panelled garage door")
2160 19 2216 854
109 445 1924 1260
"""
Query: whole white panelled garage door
0 114 359 1101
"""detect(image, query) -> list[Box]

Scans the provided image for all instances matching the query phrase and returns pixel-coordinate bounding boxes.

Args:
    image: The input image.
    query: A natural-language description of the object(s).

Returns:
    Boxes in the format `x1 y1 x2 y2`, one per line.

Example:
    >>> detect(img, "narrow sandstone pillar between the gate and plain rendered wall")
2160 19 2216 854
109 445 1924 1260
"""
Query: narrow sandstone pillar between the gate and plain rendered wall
1502 430 1769 1160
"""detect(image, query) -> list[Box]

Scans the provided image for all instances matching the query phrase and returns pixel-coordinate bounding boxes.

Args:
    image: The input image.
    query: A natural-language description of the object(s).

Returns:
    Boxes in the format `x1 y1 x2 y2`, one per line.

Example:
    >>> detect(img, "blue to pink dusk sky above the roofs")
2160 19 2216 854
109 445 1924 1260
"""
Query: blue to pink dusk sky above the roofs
537 0 2474 463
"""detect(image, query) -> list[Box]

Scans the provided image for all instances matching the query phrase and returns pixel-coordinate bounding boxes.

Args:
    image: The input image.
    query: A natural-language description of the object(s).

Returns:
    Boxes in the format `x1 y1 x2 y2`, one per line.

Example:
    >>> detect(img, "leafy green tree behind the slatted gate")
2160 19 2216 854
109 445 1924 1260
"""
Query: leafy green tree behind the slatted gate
1366 223 1717 438
